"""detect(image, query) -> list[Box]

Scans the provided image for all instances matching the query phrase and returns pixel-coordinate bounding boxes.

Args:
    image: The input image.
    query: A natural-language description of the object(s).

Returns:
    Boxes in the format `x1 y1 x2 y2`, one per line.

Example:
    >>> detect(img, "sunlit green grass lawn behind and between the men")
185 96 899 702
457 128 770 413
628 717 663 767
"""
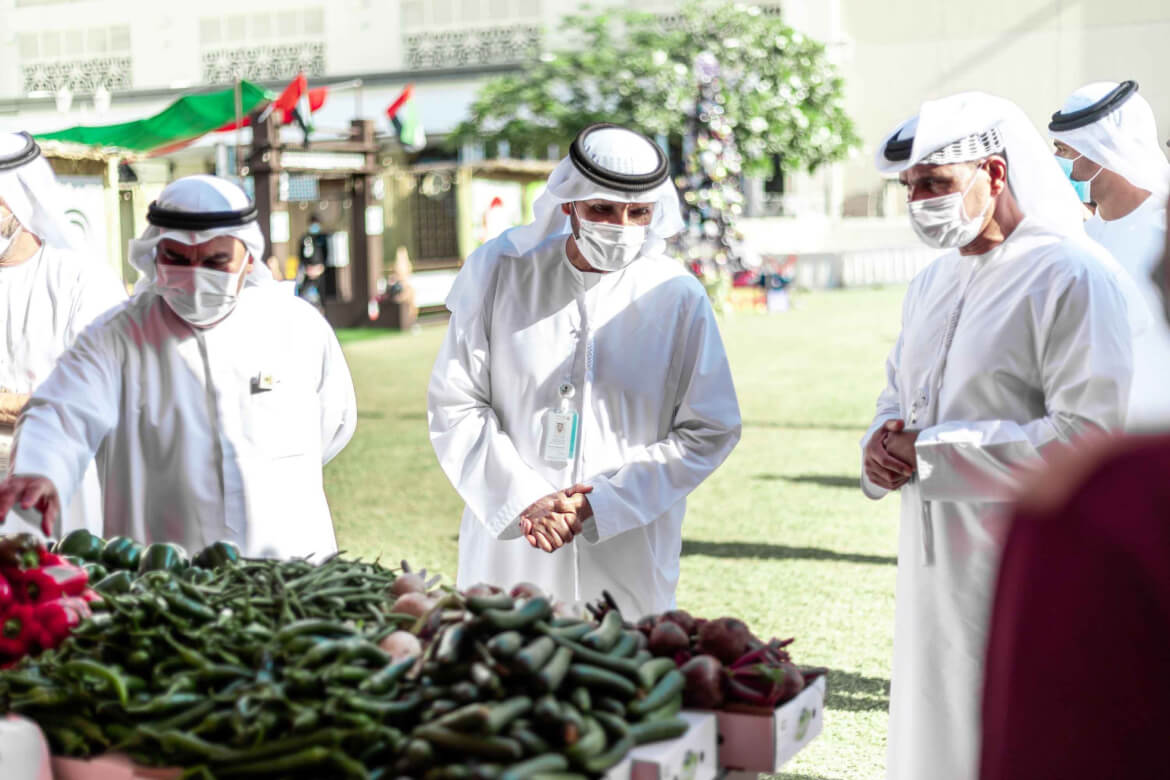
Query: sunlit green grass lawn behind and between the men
325 288 902 780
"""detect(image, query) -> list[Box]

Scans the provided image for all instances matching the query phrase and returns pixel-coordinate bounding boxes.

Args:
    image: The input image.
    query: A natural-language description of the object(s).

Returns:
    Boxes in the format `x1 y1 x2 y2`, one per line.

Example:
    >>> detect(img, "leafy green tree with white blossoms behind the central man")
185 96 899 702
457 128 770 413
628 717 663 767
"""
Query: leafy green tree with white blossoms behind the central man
452 0 859 274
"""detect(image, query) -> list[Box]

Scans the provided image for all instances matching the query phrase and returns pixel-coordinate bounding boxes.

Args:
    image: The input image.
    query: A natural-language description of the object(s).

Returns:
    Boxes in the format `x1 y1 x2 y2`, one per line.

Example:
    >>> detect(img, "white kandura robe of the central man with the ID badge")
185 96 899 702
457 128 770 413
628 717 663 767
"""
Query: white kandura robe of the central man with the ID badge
427 235 739 619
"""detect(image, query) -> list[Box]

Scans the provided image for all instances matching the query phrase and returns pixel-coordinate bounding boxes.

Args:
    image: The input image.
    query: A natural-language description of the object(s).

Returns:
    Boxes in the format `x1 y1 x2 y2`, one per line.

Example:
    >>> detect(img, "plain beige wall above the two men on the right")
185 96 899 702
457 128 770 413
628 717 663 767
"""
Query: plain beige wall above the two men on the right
841 0 1170 210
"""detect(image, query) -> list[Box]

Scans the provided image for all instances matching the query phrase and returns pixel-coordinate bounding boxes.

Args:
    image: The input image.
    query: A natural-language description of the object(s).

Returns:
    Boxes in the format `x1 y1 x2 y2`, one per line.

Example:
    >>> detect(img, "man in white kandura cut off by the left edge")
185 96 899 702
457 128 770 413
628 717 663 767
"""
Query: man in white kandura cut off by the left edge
0 133 126 533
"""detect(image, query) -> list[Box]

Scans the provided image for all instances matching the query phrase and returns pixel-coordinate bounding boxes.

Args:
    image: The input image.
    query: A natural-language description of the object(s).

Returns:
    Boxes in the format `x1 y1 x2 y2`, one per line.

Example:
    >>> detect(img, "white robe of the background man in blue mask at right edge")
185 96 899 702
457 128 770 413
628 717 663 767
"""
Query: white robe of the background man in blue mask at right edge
1085 195 1170 432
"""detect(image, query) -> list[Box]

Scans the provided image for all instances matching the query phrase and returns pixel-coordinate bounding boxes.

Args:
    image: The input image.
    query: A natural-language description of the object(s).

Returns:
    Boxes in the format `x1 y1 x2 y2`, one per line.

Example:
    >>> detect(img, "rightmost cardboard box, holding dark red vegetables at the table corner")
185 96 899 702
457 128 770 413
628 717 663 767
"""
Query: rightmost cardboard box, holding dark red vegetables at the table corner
717 675 827 773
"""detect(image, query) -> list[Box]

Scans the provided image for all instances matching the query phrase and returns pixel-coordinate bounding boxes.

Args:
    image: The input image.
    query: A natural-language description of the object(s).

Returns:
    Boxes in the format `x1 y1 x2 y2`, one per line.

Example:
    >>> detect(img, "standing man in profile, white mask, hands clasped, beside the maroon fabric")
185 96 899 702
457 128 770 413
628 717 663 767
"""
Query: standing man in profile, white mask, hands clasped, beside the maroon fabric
861 92 1133 780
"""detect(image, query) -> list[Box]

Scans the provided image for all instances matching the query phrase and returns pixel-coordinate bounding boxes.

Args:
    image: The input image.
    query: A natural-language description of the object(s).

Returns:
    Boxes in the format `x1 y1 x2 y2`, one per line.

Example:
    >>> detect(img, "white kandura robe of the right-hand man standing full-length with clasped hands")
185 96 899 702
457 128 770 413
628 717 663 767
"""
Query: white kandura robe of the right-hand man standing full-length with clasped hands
861 220 1131 780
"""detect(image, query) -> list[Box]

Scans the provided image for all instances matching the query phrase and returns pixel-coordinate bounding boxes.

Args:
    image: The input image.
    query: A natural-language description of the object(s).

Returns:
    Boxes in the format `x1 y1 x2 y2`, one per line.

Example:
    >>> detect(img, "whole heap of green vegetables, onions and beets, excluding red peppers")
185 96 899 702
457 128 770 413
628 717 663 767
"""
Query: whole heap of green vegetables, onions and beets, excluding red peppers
0 534 823 780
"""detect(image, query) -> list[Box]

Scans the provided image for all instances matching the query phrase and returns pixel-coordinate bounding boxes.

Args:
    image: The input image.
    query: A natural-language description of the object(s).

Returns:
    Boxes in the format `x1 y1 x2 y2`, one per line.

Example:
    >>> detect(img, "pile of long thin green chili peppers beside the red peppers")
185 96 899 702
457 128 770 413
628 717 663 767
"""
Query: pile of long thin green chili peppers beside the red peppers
0 557 415 778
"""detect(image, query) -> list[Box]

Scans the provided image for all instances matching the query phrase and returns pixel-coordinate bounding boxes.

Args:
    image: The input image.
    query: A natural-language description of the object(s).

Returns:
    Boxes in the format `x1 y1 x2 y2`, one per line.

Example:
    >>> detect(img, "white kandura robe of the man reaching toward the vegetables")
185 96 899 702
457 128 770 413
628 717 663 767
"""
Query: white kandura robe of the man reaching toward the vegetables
12 285 357 559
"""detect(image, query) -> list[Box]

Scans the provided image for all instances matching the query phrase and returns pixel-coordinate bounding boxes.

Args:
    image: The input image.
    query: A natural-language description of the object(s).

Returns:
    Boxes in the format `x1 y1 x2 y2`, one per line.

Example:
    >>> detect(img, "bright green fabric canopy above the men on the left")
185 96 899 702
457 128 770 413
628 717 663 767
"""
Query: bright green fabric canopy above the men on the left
36 81 273 154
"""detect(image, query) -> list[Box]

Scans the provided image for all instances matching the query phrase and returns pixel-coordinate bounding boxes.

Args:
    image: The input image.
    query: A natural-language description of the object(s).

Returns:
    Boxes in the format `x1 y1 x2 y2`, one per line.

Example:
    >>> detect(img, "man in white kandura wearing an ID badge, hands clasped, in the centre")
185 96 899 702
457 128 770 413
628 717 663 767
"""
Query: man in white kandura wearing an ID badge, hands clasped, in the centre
428 125 739 619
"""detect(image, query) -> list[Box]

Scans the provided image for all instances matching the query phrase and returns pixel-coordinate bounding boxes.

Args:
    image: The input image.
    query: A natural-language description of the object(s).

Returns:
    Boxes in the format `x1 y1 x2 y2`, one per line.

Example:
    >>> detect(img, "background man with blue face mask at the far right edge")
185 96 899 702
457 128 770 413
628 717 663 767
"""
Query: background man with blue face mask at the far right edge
1048 81 1170 430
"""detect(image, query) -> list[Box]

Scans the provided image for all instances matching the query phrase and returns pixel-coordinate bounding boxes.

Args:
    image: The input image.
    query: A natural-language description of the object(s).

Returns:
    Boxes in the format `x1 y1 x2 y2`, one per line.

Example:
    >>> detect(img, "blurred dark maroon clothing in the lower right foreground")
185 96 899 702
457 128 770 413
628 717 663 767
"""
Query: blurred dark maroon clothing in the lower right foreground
980 436 1170 780
